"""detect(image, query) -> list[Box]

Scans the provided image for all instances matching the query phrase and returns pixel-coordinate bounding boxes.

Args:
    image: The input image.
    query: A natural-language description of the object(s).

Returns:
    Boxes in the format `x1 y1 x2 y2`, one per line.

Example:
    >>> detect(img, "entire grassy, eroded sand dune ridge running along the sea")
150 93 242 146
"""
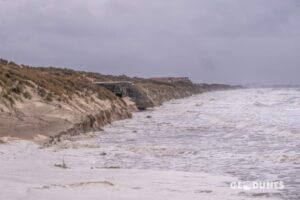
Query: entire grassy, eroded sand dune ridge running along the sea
0 59 230 142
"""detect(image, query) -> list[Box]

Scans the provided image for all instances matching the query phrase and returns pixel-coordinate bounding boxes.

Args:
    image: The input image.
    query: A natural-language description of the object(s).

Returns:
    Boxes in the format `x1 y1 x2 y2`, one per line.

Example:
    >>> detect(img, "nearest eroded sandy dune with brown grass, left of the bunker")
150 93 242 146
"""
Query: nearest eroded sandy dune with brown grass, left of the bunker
0 62 131 139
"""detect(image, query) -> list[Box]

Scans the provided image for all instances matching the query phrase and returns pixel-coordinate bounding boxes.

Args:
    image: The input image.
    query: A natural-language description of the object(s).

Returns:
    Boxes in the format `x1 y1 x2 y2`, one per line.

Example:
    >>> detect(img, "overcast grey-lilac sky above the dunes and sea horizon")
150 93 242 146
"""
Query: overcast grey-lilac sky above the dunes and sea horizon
0 0 300 84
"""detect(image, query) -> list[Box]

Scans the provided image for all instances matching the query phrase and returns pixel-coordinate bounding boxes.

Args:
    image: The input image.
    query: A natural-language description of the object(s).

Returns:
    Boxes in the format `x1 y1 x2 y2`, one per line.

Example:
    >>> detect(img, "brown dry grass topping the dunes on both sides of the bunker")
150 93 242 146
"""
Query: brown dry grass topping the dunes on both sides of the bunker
0 59 206 106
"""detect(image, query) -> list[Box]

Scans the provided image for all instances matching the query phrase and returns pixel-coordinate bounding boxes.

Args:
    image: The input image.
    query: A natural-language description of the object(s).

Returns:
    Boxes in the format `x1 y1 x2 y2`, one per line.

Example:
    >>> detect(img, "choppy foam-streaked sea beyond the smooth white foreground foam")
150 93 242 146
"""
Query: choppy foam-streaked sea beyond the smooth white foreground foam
92 89 300 199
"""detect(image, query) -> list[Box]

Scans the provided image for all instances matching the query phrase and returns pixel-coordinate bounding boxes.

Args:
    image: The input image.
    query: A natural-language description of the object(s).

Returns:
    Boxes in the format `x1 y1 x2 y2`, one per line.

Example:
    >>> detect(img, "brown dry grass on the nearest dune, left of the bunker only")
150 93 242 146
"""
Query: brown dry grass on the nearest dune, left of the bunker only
0 59 119 105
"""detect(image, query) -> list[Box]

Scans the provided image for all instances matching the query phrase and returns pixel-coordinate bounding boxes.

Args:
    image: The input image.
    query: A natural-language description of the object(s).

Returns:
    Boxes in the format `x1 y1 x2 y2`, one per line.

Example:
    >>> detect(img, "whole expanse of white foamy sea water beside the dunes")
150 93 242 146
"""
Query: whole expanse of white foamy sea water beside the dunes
0 89 300 200
